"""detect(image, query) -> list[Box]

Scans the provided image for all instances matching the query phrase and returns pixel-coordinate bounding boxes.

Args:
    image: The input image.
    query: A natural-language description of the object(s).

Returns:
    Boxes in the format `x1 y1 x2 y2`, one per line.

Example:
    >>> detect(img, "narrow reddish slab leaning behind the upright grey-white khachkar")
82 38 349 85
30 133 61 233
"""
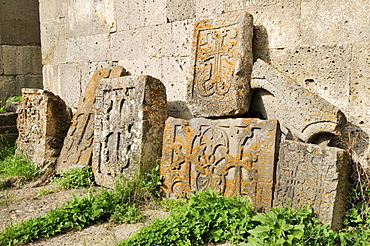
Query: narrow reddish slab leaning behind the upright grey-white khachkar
57 66 126 171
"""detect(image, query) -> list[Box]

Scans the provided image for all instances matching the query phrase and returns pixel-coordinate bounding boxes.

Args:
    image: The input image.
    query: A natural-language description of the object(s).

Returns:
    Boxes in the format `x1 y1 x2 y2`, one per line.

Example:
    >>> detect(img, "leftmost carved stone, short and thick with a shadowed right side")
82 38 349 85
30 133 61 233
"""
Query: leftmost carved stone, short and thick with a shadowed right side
17 89 71 166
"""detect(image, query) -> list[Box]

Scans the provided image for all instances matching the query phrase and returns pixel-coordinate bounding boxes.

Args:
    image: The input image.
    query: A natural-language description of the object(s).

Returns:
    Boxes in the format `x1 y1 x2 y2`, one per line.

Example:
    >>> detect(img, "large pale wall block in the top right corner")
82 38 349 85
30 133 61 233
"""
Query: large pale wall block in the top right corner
301 0 370 45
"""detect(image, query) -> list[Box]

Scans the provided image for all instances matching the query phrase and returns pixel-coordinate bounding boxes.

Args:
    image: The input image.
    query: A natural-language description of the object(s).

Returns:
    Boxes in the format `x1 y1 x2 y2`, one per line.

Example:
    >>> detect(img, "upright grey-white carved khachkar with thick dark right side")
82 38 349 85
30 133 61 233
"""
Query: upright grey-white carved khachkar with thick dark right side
92 76 167 188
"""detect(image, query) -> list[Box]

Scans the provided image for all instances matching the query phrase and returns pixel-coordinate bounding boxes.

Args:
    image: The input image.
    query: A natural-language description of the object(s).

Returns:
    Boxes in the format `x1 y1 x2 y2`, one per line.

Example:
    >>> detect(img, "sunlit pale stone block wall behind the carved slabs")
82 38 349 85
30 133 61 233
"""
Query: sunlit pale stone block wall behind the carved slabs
40 0 370 164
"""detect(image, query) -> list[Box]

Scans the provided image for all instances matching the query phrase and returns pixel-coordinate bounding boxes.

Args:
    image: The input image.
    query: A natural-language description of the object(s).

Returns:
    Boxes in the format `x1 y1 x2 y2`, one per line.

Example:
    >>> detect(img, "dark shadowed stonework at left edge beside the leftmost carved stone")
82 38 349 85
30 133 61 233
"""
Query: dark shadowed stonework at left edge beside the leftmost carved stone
0 112 18 146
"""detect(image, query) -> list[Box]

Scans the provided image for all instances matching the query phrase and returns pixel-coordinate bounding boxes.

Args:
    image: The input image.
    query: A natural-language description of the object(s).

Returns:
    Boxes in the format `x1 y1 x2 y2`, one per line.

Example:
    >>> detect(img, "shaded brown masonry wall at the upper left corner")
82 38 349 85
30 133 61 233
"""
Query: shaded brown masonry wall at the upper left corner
0 0 42 102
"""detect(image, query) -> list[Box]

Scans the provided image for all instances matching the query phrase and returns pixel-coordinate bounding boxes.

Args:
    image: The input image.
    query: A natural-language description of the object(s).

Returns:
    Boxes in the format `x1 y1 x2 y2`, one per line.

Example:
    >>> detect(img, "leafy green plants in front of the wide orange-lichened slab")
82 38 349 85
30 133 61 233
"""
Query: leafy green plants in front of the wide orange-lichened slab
119 191 252 246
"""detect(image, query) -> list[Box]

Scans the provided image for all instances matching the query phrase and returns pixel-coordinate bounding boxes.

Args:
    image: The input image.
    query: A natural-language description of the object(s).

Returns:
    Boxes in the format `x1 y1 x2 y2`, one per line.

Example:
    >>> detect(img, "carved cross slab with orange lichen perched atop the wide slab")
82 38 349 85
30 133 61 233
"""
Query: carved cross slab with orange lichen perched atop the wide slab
187 12 253 117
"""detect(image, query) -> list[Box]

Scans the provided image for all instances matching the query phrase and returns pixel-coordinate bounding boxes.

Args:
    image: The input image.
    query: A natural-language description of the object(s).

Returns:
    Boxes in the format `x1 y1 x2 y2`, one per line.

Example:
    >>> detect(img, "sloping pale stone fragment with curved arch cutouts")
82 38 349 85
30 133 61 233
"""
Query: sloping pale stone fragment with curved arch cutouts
250 59 346 143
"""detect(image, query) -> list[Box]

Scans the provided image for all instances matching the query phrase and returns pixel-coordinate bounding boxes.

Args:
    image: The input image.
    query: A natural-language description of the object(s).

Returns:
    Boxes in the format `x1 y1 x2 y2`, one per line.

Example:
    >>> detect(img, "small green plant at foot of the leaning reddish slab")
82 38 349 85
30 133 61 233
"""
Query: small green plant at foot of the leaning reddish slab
54 166 94 189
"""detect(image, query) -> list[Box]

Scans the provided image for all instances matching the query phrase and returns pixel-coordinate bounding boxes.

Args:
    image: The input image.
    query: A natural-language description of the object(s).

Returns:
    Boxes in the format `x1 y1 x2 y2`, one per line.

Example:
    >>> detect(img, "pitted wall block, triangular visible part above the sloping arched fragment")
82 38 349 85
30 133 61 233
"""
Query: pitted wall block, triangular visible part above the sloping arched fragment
255 45 352 111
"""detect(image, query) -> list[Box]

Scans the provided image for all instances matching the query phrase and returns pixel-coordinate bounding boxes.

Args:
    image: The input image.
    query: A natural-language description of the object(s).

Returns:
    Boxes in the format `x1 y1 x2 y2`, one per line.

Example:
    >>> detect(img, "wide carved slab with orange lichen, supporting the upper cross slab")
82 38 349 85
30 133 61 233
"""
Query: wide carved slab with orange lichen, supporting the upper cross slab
160 118 280 209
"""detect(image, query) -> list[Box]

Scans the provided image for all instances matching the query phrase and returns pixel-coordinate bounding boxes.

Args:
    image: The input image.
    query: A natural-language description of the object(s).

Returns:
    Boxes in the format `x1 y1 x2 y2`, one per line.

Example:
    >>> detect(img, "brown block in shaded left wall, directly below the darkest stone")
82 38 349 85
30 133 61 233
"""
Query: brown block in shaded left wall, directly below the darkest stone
1 45 42 75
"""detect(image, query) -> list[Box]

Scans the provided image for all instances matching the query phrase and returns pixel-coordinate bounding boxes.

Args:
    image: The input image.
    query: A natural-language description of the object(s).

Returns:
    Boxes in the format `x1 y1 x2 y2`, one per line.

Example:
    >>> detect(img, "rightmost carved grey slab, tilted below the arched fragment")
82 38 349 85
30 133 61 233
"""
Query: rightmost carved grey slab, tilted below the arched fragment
274 140 349 229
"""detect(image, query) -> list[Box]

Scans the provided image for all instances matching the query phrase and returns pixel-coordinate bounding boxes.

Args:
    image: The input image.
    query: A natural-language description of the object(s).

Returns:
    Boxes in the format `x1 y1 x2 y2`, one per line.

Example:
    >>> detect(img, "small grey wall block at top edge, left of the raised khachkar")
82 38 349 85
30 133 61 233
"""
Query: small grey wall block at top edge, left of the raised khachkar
166 0 195 22
